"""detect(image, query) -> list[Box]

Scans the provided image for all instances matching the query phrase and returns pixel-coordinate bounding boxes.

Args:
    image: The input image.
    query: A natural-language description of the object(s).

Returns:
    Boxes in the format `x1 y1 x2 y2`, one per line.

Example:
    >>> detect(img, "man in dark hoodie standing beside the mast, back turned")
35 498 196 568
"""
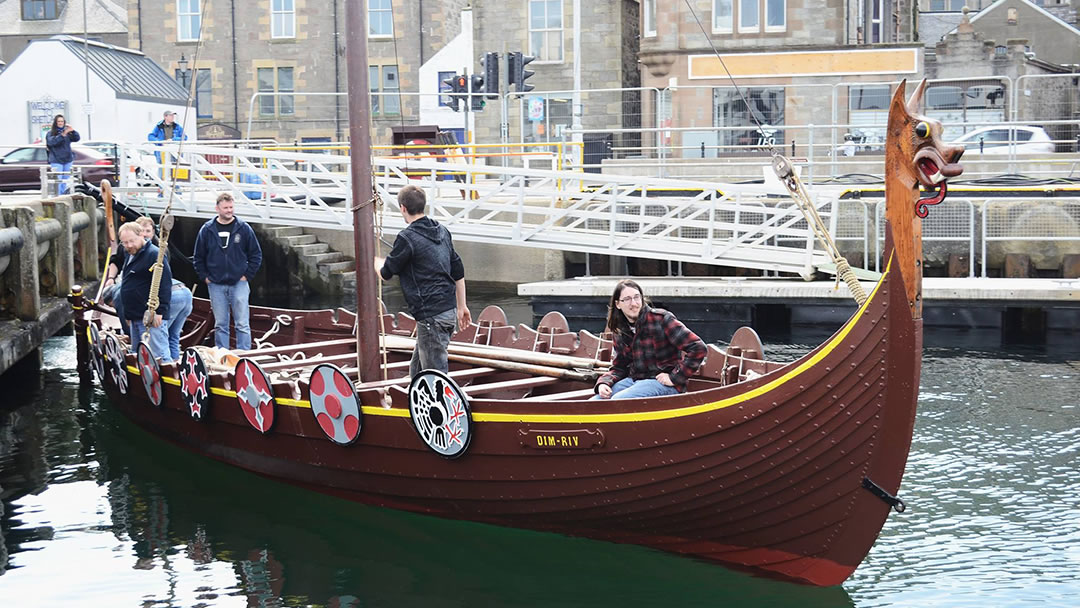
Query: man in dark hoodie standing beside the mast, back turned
375 186 472 376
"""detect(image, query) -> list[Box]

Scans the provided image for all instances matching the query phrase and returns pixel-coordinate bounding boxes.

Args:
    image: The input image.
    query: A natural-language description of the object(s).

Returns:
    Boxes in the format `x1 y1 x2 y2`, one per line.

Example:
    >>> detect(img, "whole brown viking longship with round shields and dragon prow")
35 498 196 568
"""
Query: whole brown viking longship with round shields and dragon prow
71 17 962 585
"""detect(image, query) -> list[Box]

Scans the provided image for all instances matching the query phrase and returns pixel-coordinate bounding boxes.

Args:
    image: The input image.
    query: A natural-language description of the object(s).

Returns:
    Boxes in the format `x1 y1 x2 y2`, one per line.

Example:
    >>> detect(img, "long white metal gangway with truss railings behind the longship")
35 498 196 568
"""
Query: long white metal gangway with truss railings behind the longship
117 144 836 278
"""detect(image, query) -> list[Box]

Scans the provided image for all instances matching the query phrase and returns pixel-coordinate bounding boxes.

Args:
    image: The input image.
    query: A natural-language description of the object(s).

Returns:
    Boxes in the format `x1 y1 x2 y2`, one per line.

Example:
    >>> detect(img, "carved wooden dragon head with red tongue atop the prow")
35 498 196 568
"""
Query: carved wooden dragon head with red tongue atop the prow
886 80 963 217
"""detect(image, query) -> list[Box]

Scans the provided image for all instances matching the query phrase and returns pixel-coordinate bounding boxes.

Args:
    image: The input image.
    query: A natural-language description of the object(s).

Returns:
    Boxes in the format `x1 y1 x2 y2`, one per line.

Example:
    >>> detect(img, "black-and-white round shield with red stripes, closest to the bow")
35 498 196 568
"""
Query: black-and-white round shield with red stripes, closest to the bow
408 369 472 458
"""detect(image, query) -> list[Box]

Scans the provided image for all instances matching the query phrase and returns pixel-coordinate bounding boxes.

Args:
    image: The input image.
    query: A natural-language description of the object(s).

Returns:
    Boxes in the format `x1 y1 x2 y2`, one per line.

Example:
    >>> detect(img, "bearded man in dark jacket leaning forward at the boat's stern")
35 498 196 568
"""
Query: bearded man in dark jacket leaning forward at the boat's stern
114 221 173 362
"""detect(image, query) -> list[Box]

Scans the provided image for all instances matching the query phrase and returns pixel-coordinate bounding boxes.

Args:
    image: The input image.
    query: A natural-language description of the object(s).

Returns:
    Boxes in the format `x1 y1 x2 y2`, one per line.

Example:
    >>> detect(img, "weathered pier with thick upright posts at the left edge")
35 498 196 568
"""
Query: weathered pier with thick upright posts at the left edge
0 194 103 375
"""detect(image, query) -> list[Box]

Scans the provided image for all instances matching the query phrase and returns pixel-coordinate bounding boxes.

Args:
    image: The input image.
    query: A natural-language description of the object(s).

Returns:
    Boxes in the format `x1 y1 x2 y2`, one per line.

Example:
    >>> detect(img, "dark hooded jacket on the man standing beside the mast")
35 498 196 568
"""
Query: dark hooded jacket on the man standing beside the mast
381 216 465 320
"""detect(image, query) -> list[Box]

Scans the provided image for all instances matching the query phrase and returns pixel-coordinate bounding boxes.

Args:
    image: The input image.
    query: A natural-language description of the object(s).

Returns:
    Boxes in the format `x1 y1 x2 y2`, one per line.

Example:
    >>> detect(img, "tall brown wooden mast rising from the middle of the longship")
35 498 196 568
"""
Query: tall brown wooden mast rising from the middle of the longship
345 0 380 382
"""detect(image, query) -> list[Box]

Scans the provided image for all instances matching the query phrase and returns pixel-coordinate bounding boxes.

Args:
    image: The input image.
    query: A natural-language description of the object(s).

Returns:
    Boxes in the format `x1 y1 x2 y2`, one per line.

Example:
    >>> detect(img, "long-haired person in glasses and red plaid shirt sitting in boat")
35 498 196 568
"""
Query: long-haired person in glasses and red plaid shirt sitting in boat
593 280 705 398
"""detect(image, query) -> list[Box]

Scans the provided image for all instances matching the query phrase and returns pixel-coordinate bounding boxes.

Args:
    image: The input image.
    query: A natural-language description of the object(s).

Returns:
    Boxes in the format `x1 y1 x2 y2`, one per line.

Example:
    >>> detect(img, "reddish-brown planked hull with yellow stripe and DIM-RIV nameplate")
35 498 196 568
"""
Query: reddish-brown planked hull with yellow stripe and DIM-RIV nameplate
83 226 922 585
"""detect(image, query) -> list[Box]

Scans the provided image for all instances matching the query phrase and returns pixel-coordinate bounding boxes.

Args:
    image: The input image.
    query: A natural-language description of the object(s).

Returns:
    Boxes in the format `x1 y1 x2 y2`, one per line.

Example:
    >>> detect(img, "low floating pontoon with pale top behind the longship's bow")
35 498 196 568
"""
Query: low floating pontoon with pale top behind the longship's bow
517 276 1080 339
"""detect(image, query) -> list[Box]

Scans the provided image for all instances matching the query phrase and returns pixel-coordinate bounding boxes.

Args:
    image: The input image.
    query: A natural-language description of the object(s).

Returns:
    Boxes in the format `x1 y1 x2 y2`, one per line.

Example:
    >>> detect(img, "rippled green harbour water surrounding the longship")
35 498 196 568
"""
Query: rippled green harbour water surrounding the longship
0 292 1080 608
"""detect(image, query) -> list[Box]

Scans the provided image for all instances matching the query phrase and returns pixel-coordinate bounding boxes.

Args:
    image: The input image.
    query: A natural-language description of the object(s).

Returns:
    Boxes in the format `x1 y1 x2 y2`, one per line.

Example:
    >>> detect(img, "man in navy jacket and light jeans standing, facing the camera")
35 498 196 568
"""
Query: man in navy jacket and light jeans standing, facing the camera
194 192 262 350
